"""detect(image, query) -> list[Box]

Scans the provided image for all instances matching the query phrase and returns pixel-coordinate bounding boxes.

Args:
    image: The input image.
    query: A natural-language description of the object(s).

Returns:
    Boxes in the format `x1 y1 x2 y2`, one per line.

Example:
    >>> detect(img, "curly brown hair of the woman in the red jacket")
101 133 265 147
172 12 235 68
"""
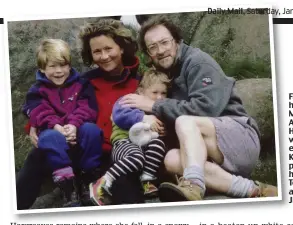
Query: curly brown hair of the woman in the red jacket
79 19 138 66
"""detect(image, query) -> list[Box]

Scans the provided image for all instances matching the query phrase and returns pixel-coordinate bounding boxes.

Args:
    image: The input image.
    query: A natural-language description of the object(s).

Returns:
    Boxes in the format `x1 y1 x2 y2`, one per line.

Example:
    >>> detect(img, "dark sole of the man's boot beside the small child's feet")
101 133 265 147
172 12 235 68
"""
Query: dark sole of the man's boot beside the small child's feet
159 183 188 202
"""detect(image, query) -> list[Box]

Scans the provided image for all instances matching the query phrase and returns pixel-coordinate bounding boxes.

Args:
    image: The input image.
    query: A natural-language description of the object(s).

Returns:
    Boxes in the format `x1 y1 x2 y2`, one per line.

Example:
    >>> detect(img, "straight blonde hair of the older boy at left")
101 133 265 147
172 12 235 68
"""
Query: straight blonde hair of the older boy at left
37 39 71 69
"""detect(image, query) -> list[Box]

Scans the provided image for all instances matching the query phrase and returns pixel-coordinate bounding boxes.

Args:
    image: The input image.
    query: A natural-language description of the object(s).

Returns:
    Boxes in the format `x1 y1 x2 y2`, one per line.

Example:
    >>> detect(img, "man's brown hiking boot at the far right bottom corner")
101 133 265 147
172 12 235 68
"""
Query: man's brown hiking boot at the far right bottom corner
249 181 278 198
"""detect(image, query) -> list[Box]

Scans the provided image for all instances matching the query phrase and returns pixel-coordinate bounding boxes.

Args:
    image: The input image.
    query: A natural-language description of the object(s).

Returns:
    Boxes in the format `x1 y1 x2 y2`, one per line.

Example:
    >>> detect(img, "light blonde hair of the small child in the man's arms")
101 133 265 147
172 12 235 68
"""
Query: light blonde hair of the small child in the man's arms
137 68 171 93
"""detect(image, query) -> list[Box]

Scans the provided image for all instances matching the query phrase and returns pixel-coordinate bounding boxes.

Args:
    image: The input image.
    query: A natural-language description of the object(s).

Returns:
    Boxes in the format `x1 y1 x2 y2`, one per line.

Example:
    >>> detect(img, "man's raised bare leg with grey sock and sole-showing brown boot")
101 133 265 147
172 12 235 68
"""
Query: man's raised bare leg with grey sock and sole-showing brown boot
159 116 208 201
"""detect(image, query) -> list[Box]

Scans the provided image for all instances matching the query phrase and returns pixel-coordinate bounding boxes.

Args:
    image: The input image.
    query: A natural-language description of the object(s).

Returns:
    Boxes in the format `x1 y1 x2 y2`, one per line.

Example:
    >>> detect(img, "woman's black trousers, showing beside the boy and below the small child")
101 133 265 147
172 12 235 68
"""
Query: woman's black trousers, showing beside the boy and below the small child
16 149 144 210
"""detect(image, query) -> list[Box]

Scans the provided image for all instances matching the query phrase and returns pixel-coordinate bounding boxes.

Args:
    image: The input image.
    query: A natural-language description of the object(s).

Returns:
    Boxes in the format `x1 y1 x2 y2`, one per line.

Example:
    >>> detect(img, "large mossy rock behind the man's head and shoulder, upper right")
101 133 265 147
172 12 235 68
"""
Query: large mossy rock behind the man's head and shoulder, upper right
137 12 271 80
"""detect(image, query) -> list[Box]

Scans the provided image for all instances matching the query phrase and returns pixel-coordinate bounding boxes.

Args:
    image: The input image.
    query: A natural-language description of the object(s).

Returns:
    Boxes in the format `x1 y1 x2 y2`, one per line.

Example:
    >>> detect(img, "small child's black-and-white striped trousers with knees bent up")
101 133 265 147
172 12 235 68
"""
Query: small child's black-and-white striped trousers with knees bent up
107 139 166 180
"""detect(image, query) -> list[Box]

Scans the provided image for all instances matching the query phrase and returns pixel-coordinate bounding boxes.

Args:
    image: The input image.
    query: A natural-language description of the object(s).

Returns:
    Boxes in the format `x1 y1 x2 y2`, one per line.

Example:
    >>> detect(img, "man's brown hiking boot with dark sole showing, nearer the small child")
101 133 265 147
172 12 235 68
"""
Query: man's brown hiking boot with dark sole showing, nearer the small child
159 177 204 202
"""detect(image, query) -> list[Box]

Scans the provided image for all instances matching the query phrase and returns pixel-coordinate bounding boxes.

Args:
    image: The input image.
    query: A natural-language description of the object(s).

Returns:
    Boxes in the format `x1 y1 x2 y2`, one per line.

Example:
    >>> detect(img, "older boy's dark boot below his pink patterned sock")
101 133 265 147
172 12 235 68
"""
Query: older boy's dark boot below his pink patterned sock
57 177 81 207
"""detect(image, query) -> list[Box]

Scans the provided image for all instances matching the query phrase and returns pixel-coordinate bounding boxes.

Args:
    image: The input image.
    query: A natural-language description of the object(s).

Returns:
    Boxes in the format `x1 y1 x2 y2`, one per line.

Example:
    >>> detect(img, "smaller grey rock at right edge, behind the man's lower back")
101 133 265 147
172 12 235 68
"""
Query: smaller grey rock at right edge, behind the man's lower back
236 78 275 153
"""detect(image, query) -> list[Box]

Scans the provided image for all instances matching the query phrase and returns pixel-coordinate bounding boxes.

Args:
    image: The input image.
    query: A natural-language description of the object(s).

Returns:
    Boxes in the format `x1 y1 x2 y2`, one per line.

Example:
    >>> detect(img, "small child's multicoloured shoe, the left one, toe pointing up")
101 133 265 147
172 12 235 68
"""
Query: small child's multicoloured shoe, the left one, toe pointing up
89 176 112 205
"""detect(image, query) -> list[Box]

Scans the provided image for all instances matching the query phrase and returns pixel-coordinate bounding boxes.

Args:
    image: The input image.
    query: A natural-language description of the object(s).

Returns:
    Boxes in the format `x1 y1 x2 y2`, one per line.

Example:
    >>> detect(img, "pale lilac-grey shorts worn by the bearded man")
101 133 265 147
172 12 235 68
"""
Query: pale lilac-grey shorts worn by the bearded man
210 116 260 177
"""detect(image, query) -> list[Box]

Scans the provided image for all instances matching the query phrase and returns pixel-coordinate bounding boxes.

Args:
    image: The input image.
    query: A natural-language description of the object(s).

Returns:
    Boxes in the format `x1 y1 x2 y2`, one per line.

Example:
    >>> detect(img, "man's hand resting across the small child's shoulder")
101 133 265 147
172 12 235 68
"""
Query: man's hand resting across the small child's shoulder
119 94 155 112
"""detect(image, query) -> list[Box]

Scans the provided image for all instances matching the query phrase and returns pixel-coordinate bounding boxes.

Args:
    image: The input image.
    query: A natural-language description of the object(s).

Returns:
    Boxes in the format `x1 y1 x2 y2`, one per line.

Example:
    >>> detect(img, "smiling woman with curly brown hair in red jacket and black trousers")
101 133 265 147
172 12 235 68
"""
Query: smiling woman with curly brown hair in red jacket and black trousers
17 19 143 209
